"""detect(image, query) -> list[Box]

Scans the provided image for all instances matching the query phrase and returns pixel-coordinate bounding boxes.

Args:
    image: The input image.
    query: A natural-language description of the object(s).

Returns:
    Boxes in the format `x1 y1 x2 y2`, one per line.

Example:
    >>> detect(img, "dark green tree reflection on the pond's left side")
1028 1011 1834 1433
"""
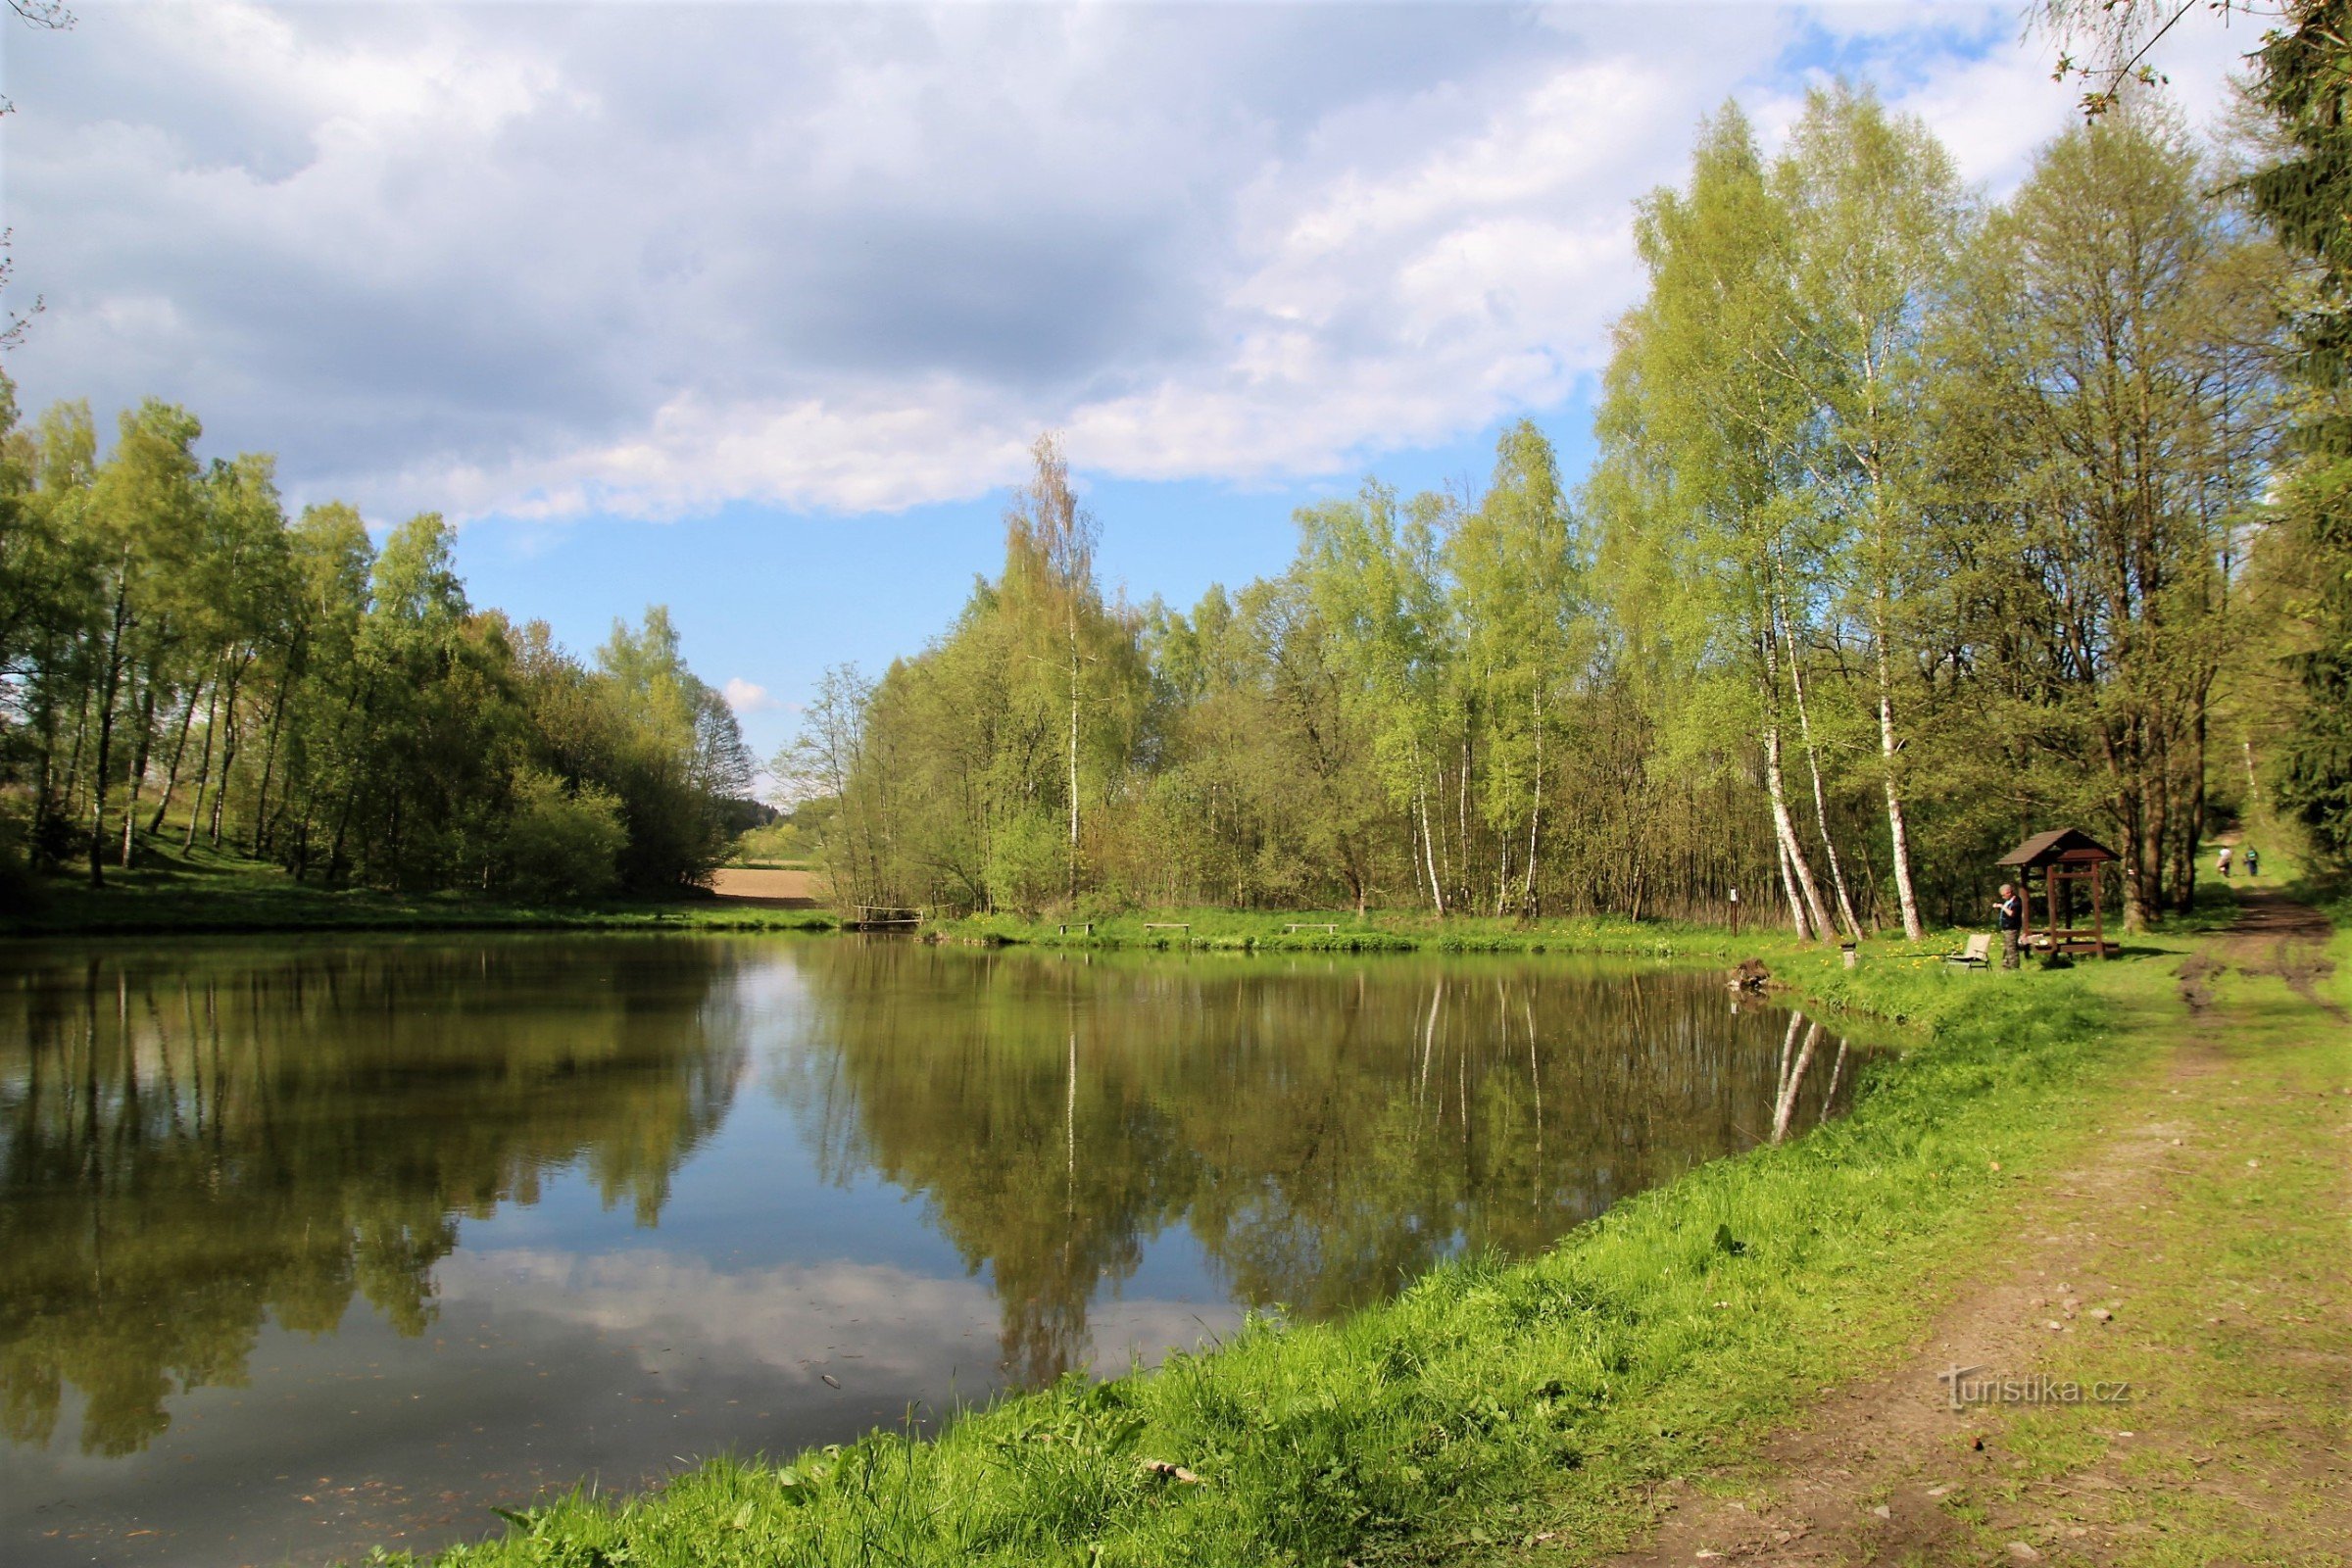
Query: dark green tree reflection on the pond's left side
0 941 741 1455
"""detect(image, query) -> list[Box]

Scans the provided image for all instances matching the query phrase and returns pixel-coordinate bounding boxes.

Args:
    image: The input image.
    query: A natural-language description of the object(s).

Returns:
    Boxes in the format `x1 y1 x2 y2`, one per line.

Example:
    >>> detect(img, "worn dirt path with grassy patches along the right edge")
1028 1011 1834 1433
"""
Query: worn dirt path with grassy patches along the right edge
1611 894 2352 1568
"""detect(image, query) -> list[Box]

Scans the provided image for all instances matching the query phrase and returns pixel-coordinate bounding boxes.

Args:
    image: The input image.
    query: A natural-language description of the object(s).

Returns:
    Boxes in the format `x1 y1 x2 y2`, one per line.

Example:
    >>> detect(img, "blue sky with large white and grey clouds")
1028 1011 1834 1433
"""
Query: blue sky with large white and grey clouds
0 0 2258 775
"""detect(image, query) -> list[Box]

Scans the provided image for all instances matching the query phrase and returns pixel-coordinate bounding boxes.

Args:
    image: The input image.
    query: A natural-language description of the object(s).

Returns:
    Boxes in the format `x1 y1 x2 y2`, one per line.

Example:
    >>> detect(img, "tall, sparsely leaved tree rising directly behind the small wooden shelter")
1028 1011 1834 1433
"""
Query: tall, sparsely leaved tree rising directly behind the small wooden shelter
1950 118 2275 917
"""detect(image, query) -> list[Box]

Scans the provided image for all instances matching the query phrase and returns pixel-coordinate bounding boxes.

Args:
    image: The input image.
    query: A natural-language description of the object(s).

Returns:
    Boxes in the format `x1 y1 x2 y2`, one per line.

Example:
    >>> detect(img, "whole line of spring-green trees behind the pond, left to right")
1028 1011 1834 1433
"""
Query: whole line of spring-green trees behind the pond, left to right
0 84 2352 938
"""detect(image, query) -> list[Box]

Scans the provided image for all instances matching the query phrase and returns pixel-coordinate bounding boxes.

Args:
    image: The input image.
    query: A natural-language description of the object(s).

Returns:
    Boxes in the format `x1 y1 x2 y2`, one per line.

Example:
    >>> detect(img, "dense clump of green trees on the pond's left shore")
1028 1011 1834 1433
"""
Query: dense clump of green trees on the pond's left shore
0 383 751 901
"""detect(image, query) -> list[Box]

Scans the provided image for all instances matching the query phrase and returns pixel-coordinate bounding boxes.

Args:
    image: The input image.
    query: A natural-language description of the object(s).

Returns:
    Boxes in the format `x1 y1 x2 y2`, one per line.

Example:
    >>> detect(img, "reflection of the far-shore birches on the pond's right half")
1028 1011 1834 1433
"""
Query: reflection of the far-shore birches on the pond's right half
781 941 1851 1382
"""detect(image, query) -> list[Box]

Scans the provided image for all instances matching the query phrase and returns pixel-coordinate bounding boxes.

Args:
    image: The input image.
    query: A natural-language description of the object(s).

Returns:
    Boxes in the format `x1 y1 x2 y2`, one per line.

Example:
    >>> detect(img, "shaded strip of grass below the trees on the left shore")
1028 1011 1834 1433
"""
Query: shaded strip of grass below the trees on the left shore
0 842 837 936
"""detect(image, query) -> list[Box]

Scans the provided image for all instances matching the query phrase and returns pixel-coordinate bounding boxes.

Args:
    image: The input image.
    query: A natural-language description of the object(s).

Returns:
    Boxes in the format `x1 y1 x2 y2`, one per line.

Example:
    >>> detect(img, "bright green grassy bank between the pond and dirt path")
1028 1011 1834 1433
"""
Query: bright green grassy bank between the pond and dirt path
362 955 2171 1566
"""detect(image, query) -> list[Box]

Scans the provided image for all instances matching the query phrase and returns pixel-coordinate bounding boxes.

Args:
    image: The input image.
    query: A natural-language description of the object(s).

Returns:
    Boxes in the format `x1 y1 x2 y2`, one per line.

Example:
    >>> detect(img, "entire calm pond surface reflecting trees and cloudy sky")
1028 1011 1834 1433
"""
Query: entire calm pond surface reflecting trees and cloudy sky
0 938 1851 1568
